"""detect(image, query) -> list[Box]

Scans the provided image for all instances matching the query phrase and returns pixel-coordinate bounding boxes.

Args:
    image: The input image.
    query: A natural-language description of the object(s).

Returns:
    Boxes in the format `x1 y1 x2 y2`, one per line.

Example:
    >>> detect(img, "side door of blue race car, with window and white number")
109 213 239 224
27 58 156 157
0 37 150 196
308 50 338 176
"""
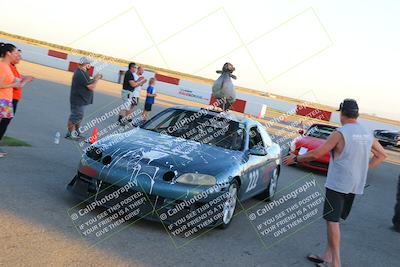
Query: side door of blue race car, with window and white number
240 125 267 199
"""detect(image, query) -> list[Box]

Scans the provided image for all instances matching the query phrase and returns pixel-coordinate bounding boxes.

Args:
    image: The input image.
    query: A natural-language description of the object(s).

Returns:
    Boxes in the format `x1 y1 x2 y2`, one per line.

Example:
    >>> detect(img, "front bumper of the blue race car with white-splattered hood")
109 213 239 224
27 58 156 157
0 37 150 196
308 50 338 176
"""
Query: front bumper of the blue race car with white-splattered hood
67 172 230 225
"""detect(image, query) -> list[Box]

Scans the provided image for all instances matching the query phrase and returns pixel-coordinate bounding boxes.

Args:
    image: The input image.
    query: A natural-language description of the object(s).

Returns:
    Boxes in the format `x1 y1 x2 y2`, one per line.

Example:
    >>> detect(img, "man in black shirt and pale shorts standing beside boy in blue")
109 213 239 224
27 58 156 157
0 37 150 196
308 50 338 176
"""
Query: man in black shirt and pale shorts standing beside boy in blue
118 62 146 125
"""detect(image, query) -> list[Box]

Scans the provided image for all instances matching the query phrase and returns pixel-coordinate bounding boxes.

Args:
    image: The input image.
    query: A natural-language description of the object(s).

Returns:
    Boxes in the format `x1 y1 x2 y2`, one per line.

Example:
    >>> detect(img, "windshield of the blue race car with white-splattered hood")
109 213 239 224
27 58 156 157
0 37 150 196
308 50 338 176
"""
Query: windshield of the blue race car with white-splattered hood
142 109 245 150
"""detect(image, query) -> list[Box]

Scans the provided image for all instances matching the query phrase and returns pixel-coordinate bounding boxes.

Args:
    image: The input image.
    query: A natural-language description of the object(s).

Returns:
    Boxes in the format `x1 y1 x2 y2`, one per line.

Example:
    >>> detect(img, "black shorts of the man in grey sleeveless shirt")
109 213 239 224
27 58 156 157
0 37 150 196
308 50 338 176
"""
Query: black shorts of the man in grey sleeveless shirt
324 188 355 222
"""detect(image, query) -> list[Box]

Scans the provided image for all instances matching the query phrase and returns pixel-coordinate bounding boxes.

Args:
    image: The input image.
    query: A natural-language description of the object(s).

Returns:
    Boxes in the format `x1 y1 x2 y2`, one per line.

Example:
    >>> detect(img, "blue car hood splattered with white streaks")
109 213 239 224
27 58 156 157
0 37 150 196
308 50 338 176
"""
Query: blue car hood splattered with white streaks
95 128 244 175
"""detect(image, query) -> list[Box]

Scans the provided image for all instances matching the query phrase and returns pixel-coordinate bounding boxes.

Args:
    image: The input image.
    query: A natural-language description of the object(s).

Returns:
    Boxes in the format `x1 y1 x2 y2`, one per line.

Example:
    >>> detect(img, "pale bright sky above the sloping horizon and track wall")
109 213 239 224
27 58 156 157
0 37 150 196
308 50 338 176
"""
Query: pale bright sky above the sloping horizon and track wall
0 0 400 120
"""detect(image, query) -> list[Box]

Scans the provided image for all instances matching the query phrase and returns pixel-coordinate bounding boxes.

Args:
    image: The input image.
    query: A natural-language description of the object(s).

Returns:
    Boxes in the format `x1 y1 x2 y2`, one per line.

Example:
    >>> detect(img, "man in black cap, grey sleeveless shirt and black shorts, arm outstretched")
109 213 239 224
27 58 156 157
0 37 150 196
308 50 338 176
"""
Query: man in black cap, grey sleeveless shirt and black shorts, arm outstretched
283 99 387 267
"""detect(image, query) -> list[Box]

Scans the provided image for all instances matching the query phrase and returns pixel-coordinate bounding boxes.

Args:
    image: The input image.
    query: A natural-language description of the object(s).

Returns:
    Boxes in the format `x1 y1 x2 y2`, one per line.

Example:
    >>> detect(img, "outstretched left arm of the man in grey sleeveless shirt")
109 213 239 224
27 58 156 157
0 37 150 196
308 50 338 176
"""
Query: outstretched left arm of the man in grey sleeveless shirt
283 131 342 165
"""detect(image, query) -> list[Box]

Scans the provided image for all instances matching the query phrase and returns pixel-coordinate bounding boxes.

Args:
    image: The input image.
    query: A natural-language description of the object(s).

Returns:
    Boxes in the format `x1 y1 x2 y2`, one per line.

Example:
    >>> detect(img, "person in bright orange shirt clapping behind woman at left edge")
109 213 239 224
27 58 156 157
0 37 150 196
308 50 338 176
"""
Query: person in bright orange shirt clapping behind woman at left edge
0 45 34 147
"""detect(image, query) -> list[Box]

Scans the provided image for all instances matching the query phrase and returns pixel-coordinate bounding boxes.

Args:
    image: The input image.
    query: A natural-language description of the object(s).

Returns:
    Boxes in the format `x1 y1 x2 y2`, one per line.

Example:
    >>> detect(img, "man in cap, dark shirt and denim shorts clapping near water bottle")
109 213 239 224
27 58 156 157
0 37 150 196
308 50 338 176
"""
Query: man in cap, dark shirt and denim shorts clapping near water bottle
65 58 102 140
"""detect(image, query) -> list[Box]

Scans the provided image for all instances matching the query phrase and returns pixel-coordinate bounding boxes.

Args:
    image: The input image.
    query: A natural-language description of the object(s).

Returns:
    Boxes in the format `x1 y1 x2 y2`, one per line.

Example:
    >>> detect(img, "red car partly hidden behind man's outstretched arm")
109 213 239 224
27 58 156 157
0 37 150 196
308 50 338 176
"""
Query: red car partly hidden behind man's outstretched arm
289 124 337 172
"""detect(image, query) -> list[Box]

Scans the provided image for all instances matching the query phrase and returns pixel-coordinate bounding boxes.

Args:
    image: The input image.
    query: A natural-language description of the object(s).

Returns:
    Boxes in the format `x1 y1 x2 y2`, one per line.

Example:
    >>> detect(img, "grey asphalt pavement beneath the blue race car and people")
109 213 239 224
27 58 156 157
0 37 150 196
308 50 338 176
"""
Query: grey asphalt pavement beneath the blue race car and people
0 76 400 266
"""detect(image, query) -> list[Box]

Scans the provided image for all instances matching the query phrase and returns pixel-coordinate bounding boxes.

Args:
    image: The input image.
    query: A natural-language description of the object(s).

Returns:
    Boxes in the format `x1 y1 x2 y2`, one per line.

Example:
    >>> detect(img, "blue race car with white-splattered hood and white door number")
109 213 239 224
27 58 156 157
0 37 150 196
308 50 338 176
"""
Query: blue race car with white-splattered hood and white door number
67 106 281 228
